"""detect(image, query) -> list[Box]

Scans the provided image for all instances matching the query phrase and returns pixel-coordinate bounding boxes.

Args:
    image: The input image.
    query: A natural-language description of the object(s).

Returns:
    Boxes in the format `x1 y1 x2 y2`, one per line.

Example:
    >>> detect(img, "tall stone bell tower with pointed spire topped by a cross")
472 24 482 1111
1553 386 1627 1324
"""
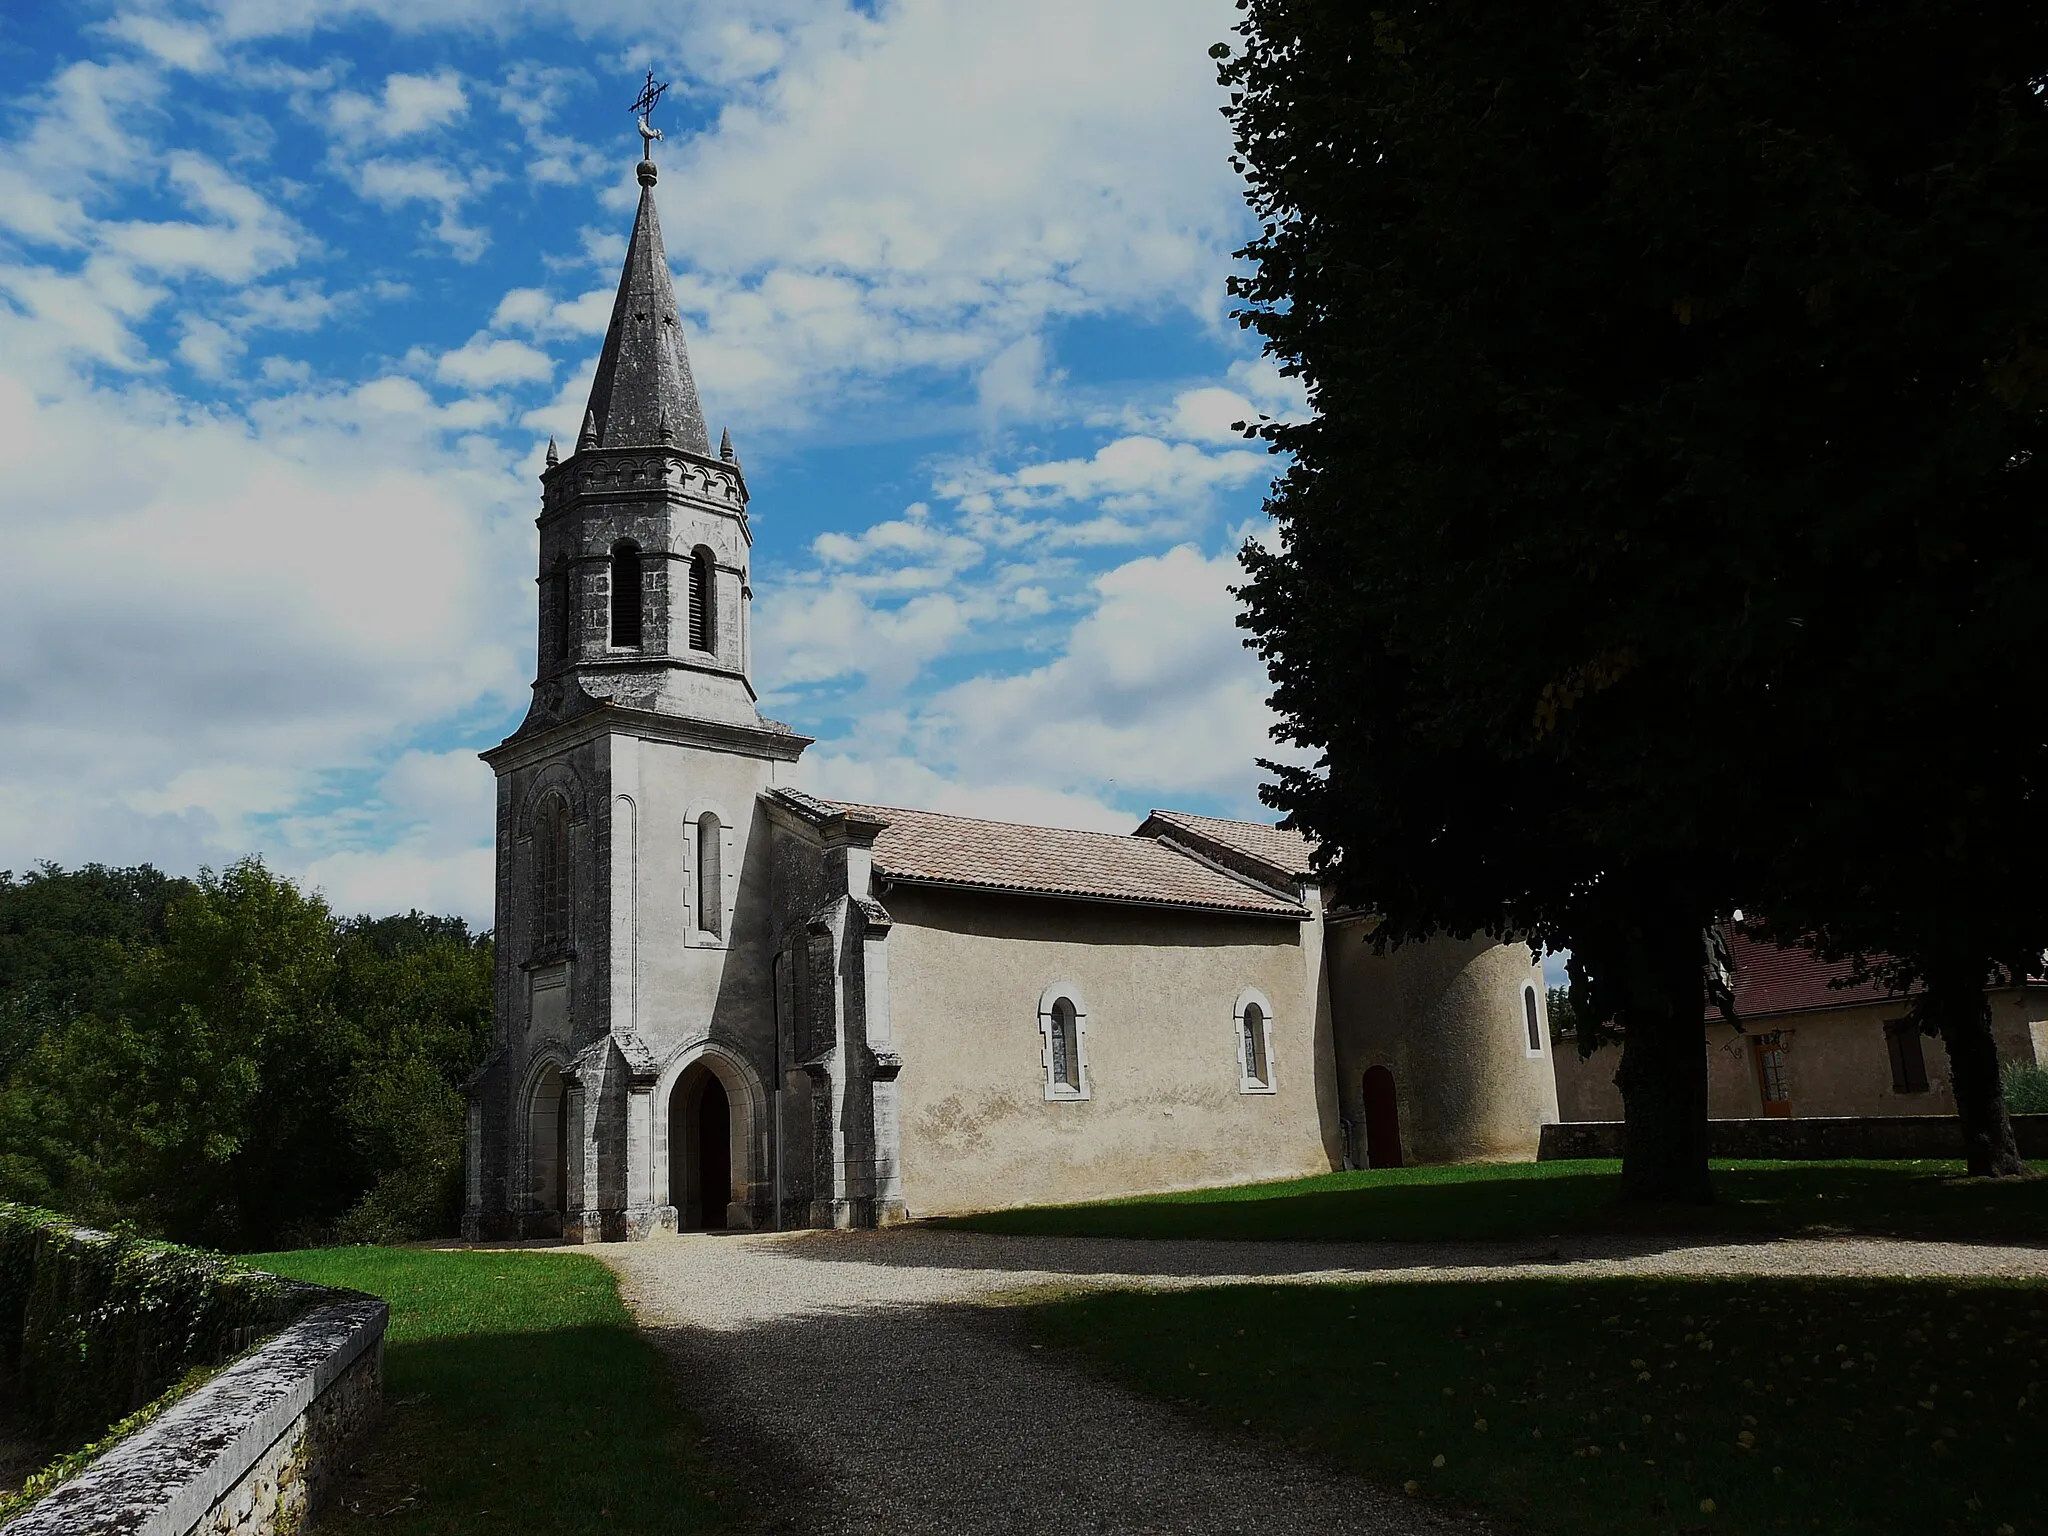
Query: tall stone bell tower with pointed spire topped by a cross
463 129 809 1241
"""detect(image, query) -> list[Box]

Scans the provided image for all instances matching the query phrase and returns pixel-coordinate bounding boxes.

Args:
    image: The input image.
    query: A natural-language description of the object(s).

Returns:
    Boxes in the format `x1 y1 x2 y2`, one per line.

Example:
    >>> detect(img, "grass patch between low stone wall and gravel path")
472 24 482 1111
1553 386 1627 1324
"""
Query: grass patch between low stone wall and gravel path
250 1247 739 1536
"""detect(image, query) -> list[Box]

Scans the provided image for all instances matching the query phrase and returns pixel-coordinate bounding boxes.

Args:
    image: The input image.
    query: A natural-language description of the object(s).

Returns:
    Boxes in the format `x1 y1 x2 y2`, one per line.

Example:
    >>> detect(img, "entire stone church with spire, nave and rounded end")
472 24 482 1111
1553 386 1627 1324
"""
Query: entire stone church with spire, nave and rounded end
465 150 1556 1241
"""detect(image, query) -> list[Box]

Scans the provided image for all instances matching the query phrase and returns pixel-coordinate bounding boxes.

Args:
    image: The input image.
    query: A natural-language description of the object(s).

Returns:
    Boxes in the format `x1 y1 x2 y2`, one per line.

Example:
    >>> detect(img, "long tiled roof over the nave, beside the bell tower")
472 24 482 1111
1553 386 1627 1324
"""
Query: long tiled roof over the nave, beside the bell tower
829 801 1307 918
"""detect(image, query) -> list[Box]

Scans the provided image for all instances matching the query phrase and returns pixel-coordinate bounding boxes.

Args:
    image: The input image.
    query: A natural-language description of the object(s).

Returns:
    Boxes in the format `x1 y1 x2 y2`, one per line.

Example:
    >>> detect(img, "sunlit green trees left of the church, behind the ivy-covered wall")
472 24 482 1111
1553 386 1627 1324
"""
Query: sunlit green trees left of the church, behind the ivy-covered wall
0 860 492 1247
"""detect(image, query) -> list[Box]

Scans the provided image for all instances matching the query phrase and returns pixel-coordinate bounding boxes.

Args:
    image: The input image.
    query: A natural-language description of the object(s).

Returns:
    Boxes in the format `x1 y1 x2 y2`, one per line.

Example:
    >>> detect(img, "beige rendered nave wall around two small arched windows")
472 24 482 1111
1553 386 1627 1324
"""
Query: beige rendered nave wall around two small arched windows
883 885 1337 1217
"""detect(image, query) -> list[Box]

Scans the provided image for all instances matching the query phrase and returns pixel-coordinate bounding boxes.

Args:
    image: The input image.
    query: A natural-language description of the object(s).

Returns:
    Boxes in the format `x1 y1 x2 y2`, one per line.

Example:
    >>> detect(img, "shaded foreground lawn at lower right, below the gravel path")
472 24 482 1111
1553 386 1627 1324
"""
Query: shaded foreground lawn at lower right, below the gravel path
1030 1280 2048 1536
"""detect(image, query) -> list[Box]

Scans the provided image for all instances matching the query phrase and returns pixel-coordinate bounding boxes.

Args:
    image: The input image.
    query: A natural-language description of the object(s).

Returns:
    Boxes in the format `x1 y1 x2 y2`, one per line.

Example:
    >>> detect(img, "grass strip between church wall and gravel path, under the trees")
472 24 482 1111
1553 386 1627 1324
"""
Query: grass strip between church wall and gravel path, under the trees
944 1159 2048 1243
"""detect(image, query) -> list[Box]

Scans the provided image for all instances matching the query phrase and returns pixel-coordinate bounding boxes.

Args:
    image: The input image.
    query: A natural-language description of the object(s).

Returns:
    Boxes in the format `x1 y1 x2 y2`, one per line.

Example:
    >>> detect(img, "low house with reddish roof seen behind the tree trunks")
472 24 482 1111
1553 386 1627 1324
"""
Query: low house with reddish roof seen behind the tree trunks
1556 932 2048 1120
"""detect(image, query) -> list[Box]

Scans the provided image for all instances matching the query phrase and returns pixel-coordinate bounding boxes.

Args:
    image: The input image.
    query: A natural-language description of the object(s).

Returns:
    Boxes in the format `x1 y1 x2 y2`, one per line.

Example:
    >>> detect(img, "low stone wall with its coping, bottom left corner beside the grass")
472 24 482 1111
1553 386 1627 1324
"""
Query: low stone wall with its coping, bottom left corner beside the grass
0 1292 389 1536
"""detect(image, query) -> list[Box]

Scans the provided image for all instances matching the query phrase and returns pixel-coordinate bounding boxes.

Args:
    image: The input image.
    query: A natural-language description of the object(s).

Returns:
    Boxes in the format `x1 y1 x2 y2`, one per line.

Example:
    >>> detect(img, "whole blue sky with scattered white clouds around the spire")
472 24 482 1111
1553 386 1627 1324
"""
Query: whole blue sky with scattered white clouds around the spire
0 0 1300 922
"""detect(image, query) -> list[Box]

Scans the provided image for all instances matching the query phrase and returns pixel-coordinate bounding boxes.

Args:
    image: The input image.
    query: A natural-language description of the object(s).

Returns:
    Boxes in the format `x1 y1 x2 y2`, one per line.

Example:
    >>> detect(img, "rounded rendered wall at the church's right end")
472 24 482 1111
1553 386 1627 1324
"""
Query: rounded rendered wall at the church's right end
1327 922 1559 1163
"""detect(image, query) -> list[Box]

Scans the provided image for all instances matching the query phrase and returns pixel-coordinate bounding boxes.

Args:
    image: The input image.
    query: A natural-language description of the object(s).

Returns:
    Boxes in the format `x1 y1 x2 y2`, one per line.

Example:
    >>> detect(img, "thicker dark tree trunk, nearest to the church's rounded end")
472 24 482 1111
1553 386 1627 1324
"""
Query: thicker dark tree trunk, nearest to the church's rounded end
1614 918 1714 1204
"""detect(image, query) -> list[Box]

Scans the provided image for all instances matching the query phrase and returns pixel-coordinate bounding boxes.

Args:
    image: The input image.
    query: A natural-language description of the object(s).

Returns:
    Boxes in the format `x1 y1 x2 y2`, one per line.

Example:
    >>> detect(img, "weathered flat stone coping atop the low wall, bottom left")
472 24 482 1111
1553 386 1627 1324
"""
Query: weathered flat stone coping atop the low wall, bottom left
0 1288 391 1536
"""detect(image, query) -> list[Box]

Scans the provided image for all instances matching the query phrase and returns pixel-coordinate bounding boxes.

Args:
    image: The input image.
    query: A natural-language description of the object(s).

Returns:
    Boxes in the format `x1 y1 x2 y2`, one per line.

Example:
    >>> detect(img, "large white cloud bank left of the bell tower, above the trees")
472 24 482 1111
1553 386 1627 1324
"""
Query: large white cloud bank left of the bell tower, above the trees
0 350 528 911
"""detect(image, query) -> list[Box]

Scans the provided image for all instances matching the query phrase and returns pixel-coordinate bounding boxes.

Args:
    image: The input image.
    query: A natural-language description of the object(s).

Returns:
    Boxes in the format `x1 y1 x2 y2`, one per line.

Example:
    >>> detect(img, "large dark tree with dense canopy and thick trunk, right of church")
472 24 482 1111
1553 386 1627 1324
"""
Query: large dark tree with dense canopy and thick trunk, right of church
1219 0 2048 1198
